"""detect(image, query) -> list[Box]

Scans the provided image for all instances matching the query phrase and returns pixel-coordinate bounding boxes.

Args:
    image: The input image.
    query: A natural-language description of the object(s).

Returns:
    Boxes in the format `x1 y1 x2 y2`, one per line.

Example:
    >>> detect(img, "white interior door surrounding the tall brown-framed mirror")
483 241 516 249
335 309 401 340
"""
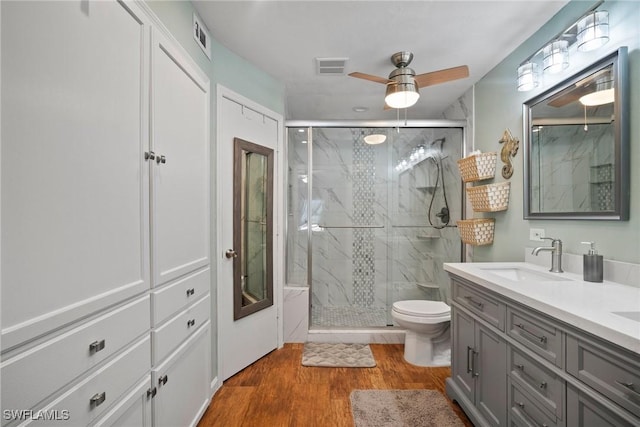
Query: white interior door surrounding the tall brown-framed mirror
217 91 279 381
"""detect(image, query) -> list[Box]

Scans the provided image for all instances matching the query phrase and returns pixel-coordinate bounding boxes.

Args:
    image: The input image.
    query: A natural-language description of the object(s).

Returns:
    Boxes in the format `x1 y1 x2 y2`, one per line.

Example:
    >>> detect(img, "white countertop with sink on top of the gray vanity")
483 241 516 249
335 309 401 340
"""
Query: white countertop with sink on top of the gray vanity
444 262 640 354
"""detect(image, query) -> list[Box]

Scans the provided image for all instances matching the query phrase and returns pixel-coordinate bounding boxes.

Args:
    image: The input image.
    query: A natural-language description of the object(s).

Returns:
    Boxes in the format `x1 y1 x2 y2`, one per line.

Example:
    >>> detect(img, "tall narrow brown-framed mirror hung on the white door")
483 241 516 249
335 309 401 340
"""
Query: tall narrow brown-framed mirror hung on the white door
233 138 273 320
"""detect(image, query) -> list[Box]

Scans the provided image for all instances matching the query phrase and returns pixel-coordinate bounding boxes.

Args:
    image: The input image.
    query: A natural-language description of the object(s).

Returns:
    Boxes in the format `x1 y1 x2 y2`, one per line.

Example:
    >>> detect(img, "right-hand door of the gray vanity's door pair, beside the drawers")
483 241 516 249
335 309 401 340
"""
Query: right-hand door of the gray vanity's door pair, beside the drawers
475 323 507 426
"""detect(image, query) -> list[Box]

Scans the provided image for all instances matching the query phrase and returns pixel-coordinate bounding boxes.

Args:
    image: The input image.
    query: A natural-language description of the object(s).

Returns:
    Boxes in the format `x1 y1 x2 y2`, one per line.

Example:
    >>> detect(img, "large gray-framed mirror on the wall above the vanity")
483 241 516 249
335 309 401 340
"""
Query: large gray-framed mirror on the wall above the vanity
523 47 629 220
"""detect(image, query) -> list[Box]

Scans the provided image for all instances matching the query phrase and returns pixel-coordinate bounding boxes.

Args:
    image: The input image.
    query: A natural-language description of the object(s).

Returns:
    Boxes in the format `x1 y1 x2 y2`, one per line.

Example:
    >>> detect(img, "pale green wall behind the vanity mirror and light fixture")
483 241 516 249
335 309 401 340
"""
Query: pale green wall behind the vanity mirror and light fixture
473 0 640 263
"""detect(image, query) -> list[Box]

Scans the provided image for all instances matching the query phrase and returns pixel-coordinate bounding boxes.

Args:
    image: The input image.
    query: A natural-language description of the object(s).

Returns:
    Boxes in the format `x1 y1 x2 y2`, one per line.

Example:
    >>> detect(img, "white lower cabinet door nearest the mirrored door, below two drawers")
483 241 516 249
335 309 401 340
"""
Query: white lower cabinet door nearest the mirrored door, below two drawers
151 322 211 427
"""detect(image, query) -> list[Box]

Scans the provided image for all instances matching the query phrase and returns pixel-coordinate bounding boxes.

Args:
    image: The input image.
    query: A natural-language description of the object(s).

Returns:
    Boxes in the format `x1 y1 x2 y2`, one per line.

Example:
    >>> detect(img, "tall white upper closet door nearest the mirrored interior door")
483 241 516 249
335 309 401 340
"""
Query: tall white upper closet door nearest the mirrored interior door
151 28 210 286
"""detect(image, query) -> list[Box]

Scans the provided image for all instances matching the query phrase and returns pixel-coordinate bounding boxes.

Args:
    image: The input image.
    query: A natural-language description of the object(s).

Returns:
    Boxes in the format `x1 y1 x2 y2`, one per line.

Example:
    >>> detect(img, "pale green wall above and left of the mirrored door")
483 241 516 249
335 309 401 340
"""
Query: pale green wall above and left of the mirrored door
146 0 284 379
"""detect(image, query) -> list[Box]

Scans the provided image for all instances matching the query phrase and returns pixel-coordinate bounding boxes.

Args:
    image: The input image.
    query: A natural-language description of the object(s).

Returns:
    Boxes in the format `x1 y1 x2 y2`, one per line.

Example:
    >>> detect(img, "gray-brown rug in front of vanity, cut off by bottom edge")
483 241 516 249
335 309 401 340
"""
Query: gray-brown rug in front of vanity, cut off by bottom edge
351 390 464 427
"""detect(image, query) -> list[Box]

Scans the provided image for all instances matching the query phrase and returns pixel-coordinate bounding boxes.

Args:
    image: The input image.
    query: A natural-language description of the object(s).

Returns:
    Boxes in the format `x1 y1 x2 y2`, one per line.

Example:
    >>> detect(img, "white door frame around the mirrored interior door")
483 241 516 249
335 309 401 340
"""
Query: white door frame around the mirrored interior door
214 84 286 378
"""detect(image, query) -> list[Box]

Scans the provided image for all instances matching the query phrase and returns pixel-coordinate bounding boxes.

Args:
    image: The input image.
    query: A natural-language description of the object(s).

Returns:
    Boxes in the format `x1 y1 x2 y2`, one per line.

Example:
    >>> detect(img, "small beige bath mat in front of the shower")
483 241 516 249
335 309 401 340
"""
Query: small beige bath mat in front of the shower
302 342 376 368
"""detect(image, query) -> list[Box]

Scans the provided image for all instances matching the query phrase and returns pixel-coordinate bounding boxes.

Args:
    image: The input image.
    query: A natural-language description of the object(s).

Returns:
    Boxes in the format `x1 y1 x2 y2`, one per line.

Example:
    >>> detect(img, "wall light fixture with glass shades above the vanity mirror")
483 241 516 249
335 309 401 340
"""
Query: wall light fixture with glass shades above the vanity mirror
517 0 609 92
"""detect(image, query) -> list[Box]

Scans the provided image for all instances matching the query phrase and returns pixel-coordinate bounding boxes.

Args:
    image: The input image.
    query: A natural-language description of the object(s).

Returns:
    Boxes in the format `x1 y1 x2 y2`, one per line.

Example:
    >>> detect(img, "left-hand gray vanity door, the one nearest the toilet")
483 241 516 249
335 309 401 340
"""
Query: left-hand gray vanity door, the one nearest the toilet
451 306 476 402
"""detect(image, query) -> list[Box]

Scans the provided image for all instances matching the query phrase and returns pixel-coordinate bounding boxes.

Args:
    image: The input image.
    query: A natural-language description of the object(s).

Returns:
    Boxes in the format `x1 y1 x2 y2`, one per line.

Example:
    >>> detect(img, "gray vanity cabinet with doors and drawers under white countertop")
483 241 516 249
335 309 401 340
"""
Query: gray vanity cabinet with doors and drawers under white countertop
446 275 640 427
